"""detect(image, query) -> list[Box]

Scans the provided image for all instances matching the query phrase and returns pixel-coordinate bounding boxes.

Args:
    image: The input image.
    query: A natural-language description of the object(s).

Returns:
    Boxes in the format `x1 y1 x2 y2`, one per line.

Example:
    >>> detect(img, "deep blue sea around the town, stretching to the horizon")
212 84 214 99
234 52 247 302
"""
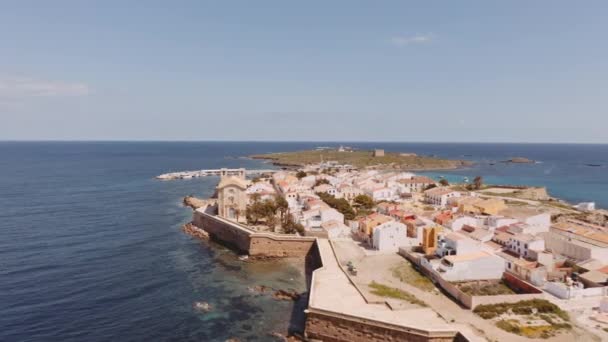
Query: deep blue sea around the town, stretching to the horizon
0 142 608 341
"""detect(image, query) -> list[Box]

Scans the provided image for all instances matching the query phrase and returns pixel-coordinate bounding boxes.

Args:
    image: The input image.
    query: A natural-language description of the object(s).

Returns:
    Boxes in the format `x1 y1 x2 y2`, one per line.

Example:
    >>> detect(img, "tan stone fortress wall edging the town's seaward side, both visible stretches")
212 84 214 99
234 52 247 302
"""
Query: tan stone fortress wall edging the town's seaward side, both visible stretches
192 207 467 342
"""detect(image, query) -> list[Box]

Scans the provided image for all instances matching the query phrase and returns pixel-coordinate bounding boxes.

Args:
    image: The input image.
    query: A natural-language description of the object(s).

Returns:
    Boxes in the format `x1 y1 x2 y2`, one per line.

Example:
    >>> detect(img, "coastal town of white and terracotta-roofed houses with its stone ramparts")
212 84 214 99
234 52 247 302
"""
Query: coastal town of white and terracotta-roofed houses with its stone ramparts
173 147 608 341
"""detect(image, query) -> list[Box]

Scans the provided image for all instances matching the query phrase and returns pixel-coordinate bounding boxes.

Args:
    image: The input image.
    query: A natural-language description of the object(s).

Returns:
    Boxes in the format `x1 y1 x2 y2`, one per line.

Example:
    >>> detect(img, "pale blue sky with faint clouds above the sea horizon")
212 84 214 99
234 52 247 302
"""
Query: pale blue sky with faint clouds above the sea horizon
0 0 608 143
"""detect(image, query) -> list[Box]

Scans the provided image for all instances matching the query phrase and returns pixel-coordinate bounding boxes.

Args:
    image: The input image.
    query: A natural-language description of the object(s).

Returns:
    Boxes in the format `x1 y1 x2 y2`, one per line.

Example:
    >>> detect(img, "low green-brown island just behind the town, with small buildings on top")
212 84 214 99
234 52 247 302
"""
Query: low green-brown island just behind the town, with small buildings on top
250 149 470 171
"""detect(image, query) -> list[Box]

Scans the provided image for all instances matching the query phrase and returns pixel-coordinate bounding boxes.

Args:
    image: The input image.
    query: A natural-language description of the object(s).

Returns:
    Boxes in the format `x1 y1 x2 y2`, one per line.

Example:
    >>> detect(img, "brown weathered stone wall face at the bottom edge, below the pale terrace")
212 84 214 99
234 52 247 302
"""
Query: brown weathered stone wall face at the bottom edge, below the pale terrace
306 311 456 342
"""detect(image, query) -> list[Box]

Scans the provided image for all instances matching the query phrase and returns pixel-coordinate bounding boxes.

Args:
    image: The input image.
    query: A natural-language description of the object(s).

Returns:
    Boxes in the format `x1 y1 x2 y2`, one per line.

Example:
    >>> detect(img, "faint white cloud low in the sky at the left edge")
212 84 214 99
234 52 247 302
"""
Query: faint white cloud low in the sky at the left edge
0 77 90 99
